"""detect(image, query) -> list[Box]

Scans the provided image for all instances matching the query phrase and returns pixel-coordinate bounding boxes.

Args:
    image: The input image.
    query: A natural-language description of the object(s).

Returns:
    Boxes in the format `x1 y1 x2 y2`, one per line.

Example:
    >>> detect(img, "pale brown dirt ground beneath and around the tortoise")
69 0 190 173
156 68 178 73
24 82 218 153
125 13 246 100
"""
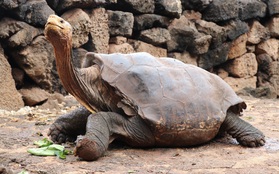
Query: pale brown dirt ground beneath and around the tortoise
0 96 279 174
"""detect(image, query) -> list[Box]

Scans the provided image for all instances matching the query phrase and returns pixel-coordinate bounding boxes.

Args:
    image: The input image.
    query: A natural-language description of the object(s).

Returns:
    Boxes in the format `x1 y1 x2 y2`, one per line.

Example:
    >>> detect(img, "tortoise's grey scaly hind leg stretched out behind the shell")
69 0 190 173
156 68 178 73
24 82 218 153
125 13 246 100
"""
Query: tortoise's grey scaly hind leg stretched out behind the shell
221 111 265 147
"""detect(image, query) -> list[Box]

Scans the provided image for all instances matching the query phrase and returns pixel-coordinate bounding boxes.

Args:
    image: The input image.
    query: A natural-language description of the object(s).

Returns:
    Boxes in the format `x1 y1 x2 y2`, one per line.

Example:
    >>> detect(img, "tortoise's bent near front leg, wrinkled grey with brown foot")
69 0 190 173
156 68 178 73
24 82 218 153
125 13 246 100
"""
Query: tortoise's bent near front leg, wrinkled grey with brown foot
74 112 155 161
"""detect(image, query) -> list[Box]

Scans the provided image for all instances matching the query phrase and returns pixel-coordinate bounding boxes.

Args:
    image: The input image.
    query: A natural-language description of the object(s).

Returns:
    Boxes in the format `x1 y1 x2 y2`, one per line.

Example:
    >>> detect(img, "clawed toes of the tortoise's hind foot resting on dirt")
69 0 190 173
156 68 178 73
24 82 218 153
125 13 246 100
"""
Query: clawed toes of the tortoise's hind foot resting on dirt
237 133 265 147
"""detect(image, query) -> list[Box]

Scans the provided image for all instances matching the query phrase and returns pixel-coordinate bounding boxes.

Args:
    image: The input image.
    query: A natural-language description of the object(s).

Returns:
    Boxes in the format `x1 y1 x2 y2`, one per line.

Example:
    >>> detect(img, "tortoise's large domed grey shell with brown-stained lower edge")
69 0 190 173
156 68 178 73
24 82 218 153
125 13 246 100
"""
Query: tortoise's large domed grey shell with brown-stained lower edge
88 53 244 146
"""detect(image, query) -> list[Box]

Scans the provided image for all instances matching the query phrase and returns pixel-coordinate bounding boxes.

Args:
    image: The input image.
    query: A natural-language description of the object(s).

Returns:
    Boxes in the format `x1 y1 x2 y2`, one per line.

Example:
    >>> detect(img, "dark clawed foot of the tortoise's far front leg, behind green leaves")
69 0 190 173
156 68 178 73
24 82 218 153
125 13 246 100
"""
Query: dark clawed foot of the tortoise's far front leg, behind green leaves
47 122 76 144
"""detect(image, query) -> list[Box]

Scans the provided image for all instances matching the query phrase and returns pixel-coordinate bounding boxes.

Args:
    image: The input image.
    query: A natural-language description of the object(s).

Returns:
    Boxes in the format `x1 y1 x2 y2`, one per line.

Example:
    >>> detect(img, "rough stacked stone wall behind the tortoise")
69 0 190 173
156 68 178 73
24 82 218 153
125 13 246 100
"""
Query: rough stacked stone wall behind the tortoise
0 0 279 109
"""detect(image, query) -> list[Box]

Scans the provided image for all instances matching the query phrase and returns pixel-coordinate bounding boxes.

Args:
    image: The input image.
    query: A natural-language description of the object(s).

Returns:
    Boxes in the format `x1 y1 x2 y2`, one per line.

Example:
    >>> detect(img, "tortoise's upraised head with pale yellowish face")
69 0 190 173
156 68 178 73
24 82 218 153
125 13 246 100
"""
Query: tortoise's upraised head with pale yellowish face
44 15 73 47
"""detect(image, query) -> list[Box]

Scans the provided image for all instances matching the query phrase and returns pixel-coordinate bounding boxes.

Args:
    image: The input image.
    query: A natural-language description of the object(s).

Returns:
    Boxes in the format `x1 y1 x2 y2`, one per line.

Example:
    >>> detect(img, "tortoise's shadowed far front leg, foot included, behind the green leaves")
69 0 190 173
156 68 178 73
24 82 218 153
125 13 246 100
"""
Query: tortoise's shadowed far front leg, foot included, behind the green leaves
48 107 91 144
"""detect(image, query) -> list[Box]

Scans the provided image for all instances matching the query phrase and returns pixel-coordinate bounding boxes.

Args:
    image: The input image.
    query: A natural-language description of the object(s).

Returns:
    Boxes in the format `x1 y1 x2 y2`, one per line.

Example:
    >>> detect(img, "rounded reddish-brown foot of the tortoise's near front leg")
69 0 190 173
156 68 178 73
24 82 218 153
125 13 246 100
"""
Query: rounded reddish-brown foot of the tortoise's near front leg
74 136 105 161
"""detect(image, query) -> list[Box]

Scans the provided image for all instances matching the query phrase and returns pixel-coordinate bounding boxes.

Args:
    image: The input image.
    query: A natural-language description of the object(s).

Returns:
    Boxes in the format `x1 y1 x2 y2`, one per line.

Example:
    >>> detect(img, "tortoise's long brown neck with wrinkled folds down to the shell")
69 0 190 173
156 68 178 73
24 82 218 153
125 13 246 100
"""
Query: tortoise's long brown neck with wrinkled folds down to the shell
53 39 116 112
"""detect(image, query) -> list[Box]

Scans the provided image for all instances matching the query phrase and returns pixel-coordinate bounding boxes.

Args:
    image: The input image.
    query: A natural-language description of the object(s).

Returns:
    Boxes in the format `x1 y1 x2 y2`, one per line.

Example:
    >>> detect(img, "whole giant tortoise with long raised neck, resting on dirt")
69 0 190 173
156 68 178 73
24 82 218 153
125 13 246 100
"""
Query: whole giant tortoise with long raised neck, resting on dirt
45 15 265 160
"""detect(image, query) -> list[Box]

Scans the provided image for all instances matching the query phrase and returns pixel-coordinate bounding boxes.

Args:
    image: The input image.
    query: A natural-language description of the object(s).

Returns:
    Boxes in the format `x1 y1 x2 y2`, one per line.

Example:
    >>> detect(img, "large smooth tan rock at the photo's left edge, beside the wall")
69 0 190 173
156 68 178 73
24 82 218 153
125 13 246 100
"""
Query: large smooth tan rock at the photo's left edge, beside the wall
0 46 24 110
